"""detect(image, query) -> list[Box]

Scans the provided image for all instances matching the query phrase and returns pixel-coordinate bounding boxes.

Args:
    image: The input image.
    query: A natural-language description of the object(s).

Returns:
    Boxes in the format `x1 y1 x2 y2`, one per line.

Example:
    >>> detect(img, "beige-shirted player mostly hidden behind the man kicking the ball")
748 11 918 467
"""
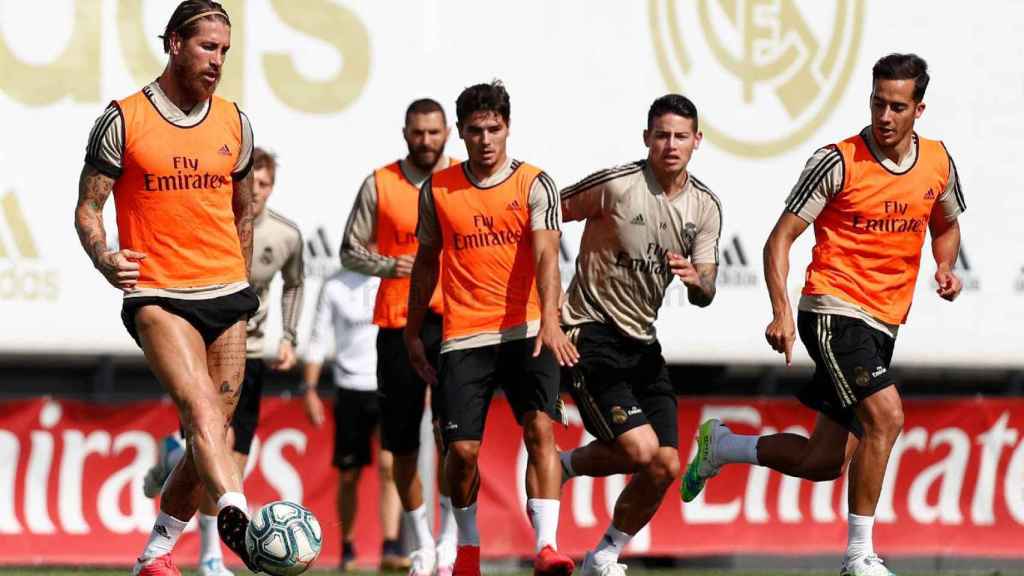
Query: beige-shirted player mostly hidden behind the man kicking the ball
143 148 304 576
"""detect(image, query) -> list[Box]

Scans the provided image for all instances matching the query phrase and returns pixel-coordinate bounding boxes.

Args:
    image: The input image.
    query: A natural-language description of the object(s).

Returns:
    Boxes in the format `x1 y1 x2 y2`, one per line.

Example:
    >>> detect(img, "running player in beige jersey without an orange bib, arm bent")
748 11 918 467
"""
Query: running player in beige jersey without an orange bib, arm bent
561 94 722 576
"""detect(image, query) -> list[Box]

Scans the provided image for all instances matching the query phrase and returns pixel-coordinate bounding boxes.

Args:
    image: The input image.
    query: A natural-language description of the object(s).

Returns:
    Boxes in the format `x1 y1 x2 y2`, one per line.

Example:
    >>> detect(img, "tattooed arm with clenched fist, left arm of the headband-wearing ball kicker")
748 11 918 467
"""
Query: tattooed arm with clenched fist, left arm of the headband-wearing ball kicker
75 164 145 292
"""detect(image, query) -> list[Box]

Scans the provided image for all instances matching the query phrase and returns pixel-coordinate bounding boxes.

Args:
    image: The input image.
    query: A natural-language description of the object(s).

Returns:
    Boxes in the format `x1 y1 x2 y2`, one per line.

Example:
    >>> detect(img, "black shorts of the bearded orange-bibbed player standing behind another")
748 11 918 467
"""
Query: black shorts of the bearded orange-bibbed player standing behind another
377 313 441 454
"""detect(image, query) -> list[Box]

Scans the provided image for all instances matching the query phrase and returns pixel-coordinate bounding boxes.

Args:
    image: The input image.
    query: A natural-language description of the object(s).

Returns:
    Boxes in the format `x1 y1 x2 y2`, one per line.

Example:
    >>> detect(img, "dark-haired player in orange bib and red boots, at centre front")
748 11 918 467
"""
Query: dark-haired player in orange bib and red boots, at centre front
404 81 577 576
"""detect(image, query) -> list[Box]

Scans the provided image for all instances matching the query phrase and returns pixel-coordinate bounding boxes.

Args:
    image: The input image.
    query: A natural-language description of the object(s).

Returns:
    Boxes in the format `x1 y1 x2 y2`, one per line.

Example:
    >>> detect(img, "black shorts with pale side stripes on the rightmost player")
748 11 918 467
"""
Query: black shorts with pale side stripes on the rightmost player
797 311 896 437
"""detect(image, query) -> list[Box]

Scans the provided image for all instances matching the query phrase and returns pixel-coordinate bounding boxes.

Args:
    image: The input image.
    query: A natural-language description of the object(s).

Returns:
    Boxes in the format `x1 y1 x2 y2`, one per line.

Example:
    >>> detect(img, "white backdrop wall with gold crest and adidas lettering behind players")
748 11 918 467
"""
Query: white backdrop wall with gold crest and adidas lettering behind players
0 0 1024 366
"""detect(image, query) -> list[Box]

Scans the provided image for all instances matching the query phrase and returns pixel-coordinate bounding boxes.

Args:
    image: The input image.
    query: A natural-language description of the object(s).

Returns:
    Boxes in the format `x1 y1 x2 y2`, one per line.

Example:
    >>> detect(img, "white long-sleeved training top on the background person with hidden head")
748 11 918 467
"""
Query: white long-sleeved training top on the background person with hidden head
306 270 380 390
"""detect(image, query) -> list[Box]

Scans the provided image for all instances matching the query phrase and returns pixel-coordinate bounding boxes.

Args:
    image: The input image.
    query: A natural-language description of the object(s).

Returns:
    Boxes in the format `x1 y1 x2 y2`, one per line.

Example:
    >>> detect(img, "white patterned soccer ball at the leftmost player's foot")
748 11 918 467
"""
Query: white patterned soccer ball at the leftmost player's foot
246 500 323 576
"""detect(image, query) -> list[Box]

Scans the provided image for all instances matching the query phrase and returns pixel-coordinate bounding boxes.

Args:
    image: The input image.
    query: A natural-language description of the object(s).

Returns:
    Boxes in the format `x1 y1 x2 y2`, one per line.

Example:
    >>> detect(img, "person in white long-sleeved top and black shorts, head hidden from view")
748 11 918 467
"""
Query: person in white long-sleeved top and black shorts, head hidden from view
303 270 409 571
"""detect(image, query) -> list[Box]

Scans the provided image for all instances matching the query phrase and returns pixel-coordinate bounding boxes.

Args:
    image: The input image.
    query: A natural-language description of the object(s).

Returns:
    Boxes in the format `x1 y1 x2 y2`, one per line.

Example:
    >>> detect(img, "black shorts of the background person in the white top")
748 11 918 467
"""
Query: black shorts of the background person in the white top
334 388 381 470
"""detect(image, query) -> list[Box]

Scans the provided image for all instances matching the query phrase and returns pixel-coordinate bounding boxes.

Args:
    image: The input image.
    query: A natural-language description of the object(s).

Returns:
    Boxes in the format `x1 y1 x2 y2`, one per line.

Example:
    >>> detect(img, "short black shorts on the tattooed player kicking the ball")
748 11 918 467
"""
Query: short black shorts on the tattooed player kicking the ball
121 286 259 346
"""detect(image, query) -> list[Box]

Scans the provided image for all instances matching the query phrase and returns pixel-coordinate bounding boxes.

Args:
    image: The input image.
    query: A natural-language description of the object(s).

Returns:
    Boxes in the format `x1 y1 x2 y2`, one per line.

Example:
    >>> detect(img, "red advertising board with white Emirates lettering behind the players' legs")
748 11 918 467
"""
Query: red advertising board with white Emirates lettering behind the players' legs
0 398 1024 567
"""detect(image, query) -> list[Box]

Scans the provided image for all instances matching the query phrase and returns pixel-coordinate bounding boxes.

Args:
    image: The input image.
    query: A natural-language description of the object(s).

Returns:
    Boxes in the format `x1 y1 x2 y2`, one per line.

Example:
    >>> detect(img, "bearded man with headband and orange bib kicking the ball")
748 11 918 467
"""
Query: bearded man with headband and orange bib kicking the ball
75 0 259 576
